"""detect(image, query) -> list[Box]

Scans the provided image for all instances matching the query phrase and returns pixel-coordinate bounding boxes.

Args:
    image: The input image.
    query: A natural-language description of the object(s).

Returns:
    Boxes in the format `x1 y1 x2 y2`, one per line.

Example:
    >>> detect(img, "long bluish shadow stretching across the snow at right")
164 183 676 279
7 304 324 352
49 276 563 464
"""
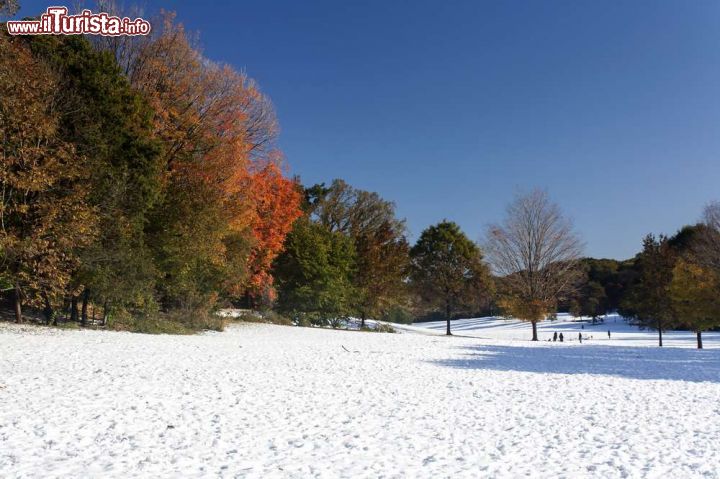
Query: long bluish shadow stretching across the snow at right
431 345 720 382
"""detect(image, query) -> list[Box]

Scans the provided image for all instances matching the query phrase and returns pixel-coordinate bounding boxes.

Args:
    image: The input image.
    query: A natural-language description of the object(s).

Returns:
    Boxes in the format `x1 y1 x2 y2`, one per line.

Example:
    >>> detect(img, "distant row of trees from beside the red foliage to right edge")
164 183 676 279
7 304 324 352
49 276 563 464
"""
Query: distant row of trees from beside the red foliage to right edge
275 184 720 348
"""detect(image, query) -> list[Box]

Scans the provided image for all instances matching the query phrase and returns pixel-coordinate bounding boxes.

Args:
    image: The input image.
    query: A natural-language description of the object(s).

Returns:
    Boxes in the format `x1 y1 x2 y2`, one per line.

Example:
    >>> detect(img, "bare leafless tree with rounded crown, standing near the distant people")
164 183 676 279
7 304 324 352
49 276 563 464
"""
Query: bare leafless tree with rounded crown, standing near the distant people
485 190 583 341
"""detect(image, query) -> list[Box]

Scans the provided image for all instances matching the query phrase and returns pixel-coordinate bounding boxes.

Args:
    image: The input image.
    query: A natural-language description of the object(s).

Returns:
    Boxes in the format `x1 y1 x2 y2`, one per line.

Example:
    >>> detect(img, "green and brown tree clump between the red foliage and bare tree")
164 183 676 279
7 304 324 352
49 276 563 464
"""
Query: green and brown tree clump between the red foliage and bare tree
274 180 492 334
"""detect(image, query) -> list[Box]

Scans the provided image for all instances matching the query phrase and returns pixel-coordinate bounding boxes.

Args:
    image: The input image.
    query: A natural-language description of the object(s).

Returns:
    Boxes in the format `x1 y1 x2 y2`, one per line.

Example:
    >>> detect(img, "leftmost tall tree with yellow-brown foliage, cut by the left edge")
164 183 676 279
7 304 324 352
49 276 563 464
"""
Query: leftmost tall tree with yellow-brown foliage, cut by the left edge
0 32 96 322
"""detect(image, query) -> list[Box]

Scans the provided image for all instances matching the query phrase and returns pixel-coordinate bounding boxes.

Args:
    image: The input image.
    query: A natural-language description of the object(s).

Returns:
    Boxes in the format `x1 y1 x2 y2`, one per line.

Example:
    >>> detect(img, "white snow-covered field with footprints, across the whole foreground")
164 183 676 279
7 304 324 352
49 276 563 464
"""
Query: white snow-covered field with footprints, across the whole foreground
0 320 720 478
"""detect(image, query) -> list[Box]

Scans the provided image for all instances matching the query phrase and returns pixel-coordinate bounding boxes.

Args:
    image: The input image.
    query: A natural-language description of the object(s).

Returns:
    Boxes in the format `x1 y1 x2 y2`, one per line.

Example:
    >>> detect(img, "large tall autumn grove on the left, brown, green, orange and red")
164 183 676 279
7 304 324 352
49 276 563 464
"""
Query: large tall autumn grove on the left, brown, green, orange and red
0 14 301 334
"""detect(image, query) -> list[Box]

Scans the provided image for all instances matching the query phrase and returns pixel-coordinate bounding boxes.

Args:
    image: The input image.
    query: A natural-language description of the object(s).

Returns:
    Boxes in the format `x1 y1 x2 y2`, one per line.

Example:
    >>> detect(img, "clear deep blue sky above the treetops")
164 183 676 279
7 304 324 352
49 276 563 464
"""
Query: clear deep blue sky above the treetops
15 0 720 258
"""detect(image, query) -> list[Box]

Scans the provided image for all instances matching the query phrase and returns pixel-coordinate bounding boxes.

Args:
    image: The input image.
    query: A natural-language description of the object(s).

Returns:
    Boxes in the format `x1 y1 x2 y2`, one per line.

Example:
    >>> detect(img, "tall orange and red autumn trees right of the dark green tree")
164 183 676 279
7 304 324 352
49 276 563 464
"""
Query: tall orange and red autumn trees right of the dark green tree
96 13 300 312
